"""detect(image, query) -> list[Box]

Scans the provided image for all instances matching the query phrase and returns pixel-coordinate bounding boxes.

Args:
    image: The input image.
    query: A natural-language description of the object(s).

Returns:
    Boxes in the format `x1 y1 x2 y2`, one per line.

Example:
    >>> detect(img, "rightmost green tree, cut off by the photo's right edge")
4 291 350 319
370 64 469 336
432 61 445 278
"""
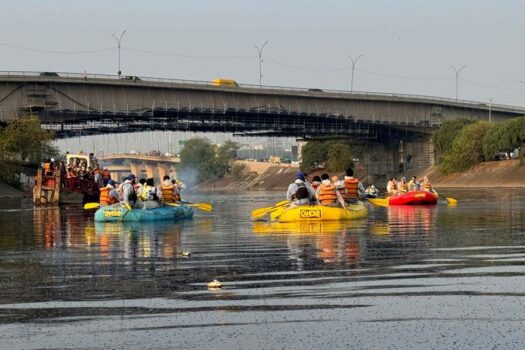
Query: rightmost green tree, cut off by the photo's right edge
483 117 525 160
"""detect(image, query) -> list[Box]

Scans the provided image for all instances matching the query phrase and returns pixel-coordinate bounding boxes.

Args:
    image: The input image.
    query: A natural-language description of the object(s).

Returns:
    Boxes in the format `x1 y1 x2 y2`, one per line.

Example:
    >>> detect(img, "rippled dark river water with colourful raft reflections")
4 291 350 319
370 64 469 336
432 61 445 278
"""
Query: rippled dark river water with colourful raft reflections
0 190 525 349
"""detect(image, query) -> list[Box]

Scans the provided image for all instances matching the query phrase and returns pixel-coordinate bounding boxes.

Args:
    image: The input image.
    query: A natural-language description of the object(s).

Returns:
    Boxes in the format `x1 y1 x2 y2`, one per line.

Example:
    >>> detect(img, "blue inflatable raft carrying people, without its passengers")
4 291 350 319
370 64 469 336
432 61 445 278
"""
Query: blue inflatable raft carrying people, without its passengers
95 204 193 222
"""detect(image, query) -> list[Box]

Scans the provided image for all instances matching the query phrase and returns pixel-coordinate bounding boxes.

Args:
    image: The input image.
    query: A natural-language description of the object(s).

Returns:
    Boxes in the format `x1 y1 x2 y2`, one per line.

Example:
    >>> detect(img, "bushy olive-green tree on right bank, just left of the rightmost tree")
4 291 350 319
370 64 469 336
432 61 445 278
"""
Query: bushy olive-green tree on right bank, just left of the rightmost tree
440 121 491 174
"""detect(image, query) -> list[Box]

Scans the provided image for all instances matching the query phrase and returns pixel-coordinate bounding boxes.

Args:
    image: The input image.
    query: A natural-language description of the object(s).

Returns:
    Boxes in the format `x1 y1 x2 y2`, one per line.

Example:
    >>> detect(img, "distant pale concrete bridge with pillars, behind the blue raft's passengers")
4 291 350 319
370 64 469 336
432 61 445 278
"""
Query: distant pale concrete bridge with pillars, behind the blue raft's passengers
98 153 180 181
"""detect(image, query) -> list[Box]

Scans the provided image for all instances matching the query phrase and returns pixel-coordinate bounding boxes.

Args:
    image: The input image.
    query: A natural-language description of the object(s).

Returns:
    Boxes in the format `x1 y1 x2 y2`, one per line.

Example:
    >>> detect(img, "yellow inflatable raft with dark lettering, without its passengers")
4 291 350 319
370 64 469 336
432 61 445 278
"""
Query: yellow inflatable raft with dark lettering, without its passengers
270 202 368 222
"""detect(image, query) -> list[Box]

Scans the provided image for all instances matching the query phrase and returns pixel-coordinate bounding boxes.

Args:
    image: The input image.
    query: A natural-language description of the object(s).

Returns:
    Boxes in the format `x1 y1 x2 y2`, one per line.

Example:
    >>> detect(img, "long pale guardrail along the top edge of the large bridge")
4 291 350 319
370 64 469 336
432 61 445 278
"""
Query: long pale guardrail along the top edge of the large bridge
0 71 525 113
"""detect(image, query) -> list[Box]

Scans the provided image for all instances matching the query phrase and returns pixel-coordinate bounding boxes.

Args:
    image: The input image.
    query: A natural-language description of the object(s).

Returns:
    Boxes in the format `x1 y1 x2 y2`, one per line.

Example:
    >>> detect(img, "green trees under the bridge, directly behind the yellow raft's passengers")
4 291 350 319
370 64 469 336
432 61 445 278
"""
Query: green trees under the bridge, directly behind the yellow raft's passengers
301 141 353 171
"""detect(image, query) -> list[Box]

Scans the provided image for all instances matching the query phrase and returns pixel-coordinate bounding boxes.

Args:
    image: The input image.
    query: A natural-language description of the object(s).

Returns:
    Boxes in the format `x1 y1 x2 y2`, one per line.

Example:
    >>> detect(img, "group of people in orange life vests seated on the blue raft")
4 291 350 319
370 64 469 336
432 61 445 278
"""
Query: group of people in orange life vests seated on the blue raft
100 174 185 209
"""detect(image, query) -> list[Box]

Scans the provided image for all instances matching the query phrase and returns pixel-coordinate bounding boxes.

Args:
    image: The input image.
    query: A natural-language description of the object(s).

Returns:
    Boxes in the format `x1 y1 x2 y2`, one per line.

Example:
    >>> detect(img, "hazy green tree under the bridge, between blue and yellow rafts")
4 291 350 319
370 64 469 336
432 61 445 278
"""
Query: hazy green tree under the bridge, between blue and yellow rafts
179 137 239 184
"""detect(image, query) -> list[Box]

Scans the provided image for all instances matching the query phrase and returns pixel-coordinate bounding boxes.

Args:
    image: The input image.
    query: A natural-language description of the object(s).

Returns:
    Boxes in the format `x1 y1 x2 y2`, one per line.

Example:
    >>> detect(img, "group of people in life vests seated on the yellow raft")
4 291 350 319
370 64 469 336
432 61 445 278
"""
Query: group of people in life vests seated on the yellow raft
286 168 366 208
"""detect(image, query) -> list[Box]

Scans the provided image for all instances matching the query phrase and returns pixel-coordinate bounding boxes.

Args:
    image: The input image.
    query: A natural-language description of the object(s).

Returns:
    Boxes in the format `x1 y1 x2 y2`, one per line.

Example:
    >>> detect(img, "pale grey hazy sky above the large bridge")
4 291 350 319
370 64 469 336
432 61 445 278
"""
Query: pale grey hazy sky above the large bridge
4 0 525 152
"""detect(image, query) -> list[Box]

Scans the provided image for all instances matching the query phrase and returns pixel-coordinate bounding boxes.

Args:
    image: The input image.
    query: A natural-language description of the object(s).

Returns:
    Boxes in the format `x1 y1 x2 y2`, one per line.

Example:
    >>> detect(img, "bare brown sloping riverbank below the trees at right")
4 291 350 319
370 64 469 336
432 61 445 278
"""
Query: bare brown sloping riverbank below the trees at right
419 159 525 188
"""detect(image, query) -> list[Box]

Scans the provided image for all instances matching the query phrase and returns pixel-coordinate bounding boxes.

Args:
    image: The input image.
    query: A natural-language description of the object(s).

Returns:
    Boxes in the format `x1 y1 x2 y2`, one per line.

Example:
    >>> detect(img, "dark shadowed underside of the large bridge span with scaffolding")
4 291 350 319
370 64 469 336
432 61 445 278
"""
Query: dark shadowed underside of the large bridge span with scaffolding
39 108 434 141
